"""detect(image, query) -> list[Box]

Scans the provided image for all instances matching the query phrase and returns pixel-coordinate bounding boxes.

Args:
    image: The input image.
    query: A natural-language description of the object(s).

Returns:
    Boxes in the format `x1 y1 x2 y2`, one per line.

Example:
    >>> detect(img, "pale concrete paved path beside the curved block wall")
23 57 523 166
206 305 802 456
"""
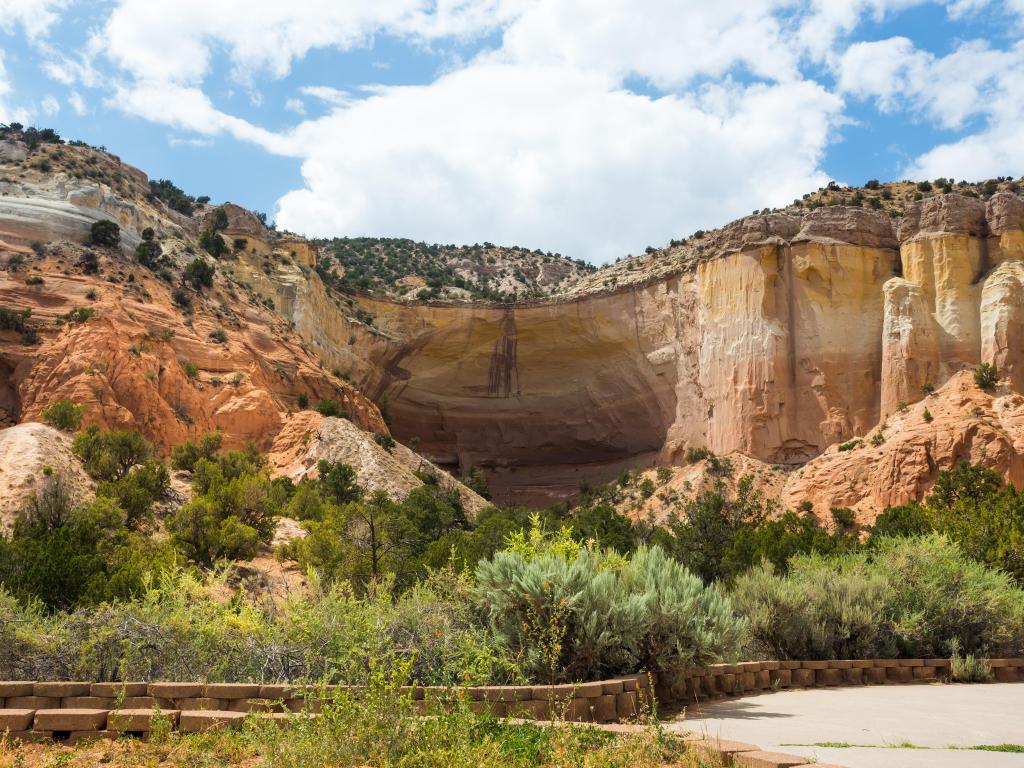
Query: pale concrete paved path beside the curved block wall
669 683 1024 768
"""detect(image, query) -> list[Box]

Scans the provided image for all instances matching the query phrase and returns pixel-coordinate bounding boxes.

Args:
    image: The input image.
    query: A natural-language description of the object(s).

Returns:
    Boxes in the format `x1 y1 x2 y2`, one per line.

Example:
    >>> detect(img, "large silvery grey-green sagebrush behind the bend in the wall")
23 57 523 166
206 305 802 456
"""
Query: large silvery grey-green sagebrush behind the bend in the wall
475 524 745 684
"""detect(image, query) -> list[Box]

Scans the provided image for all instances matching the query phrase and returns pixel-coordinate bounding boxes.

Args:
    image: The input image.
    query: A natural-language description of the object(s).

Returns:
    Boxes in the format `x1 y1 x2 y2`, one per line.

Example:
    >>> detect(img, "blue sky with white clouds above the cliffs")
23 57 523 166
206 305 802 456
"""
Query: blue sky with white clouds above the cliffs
0 0 1024 264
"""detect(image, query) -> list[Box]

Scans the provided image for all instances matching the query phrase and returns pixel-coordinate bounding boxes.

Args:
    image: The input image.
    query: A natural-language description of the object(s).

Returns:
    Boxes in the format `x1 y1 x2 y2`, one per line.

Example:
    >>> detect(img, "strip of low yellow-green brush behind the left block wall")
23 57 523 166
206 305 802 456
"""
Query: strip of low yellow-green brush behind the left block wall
0 569 524 688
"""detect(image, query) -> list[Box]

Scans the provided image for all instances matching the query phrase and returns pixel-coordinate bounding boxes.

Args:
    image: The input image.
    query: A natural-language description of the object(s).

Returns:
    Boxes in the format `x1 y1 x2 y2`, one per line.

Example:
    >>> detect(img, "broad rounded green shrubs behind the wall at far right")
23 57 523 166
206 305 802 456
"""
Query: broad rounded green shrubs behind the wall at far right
733 534 1024 658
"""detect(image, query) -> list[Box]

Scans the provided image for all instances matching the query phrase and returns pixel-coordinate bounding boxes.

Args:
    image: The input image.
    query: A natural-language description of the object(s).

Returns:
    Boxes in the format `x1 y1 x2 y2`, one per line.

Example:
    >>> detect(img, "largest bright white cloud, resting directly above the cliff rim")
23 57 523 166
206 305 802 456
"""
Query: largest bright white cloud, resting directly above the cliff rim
276 62 841 261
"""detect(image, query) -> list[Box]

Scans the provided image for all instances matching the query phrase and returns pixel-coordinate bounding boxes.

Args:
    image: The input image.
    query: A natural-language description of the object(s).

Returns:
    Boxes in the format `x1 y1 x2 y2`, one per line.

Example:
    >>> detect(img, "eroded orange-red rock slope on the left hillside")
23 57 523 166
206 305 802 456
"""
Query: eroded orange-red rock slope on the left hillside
0 246 387 450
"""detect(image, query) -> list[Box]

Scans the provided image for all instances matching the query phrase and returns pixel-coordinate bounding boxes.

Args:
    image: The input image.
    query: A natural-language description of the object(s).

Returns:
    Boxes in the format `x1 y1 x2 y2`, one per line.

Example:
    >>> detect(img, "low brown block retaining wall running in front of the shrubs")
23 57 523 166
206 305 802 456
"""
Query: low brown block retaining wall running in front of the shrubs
0 658 1024 742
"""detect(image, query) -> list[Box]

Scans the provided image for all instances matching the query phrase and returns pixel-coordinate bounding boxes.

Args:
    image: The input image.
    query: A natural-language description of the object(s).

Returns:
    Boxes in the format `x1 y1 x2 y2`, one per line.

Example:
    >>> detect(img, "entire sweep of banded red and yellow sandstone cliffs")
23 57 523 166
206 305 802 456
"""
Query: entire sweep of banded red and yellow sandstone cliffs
0 134 1024 514
